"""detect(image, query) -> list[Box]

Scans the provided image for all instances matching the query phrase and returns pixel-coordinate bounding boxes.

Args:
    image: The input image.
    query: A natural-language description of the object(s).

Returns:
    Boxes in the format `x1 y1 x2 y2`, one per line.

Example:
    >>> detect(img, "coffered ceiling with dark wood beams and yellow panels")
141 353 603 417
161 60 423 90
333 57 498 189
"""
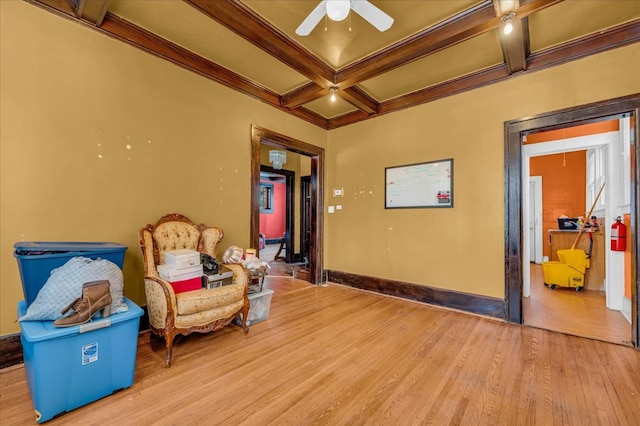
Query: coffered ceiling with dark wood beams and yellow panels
27 0 640 129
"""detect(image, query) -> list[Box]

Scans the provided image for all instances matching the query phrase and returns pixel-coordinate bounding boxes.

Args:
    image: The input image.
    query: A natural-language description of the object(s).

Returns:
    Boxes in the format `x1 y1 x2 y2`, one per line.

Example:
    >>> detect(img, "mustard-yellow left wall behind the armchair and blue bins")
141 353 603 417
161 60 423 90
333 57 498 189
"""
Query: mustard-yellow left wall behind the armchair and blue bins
0 1 327 335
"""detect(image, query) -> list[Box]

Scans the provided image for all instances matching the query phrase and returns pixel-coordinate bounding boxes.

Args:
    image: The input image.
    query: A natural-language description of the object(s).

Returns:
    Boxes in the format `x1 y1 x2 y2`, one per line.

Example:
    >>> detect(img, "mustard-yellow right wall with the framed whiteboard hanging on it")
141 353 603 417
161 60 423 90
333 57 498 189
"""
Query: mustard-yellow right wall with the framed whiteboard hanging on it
325 43 640 298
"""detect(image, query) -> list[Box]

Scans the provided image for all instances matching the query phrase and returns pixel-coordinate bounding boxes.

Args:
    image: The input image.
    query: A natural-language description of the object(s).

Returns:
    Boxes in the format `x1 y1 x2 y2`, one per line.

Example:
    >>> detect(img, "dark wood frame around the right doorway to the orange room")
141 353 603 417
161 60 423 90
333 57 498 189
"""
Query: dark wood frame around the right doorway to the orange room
504 94 640 347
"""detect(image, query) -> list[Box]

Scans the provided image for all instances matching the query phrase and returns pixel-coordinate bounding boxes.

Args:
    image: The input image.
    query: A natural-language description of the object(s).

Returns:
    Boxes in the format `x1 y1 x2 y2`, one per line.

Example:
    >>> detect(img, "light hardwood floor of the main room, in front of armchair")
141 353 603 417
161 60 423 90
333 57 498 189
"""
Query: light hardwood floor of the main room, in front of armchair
0 277 640 426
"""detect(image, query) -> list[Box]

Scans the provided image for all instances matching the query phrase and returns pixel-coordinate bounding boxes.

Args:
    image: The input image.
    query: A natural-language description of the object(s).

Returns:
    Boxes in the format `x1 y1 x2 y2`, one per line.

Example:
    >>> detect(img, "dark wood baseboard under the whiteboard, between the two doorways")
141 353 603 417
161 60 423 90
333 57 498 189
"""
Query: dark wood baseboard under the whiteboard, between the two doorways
326 270 506 319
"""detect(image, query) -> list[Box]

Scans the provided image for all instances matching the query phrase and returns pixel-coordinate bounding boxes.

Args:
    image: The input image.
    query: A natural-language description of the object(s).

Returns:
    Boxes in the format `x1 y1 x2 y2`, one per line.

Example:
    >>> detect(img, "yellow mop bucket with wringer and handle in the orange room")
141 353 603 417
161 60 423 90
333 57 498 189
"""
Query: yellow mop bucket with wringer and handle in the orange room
542 184 604 292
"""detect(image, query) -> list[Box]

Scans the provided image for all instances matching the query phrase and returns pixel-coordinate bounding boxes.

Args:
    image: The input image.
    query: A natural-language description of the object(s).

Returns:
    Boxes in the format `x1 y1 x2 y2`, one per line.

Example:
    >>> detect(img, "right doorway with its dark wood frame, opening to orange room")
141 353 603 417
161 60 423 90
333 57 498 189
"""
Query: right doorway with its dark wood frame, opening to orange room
505 95 640 347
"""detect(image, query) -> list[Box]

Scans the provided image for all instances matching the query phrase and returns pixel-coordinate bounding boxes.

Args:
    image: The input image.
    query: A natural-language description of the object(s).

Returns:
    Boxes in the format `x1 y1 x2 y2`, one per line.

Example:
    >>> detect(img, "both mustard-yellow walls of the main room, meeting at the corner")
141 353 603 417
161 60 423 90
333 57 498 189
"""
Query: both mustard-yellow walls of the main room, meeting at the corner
0 1 640 334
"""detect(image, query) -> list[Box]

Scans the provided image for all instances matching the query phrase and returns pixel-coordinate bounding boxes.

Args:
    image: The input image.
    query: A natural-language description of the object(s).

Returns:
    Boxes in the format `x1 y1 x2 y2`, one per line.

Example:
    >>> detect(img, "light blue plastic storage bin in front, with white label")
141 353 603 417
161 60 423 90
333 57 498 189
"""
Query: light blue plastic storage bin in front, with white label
18 297 142 423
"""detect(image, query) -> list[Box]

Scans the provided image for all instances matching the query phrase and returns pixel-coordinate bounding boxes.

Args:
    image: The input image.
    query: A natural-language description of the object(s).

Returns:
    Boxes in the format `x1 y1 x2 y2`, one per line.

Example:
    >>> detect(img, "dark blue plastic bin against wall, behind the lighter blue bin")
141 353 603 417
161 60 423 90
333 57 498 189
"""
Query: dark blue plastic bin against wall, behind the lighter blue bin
13 241 127 306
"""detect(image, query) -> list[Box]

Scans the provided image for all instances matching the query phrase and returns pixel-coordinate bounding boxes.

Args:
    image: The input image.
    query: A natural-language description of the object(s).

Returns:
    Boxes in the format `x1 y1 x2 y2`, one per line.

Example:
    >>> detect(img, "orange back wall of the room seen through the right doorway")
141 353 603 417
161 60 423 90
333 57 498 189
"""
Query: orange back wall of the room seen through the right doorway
529 151 587 257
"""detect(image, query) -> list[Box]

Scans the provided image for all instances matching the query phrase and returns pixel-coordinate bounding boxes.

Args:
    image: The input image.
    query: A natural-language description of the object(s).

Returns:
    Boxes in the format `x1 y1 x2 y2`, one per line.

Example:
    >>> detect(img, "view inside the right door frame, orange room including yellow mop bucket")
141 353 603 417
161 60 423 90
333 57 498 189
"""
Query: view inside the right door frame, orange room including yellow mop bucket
523 115 632 344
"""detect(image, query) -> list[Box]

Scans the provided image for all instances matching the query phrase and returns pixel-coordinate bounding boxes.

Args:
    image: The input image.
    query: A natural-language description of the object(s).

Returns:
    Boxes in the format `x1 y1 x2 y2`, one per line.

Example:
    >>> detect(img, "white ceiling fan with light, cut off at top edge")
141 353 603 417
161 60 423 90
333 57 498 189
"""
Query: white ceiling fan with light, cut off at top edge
296 0 393 36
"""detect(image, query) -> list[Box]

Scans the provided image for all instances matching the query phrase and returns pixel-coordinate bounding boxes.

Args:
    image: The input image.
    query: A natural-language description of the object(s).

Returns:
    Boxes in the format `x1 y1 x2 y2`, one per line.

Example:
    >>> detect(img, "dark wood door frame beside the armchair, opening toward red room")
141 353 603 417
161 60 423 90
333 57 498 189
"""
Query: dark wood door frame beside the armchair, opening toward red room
249 125 326 284
